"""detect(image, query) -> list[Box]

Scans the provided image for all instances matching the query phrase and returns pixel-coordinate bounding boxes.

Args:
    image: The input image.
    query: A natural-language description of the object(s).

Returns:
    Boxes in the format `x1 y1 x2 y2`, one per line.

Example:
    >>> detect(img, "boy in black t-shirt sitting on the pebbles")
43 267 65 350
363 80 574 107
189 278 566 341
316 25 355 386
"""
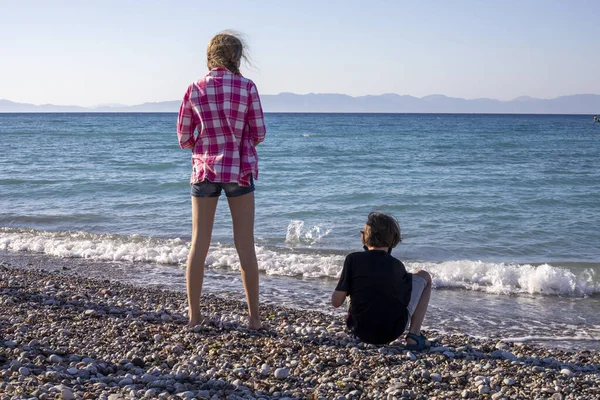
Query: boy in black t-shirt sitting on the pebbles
331 212 431 350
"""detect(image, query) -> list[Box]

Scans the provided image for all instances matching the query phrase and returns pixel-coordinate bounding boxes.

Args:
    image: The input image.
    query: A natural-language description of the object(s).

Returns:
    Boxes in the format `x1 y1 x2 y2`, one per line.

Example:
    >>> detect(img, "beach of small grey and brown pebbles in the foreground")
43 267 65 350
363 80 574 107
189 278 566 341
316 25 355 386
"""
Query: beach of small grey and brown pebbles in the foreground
0 262 600 400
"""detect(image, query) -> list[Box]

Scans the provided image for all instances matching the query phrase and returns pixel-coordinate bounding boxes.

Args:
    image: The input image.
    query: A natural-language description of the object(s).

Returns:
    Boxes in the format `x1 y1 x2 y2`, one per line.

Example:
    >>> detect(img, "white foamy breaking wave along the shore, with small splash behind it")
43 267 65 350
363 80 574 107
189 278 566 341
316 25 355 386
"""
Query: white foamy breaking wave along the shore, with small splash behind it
0 228 600 297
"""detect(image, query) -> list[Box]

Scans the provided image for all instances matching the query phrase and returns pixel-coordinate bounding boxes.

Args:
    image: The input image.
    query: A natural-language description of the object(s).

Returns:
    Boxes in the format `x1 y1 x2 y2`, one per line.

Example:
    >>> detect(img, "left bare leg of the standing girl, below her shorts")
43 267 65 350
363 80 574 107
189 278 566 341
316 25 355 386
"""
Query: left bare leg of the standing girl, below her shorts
186 196 219 326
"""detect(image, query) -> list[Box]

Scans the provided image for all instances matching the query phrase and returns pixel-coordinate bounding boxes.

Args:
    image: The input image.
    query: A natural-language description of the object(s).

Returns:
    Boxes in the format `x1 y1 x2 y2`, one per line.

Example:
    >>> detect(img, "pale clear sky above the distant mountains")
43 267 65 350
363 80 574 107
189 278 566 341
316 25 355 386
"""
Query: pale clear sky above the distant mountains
0 0 600 106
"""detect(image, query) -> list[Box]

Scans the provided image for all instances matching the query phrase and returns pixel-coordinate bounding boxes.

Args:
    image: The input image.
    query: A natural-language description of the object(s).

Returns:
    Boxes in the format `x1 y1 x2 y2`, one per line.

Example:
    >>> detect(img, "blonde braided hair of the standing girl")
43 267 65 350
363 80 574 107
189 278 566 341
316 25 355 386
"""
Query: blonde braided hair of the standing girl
206 31 248 75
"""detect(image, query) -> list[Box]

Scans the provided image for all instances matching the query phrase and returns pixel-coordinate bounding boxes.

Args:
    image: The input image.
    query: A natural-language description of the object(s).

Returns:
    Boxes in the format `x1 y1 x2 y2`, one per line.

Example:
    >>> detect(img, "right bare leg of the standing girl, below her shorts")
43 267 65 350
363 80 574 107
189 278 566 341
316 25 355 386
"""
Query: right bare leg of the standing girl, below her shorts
227 192 262 329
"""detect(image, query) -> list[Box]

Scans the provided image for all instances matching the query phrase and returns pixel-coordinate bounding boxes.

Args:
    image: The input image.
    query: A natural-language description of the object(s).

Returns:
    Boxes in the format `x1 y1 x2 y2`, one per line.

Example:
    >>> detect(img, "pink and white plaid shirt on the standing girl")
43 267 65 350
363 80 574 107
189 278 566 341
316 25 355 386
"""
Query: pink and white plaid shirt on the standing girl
177 68 266 186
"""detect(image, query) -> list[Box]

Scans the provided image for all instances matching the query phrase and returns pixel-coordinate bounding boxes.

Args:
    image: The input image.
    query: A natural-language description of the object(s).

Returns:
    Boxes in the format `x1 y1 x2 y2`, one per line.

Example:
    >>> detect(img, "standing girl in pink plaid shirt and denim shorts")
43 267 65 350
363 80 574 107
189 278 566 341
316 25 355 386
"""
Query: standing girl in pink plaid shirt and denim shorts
177 32 266 329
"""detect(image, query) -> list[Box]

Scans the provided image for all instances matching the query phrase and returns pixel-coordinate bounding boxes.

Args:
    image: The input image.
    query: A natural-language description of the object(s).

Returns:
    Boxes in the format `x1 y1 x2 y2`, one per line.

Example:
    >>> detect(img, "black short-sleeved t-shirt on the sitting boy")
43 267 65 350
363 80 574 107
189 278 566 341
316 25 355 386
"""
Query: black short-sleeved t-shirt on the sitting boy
335 250 412 344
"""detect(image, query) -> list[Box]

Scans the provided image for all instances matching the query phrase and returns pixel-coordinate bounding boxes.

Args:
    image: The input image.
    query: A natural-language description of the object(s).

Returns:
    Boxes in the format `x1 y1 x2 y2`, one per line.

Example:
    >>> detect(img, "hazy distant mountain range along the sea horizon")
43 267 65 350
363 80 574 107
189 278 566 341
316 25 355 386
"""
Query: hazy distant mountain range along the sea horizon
0 93 600 114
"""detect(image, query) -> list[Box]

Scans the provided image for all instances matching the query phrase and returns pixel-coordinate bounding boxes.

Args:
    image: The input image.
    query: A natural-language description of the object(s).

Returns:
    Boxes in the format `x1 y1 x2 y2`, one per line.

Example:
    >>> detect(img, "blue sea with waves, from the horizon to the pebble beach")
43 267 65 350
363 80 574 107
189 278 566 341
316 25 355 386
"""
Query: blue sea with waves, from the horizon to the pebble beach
0 113 600 350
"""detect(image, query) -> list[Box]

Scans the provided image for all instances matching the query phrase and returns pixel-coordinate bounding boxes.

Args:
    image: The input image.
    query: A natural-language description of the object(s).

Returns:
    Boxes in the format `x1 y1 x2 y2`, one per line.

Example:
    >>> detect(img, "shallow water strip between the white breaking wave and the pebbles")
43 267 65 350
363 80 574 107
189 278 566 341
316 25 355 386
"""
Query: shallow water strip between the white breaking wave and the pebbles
0 251 600 351
